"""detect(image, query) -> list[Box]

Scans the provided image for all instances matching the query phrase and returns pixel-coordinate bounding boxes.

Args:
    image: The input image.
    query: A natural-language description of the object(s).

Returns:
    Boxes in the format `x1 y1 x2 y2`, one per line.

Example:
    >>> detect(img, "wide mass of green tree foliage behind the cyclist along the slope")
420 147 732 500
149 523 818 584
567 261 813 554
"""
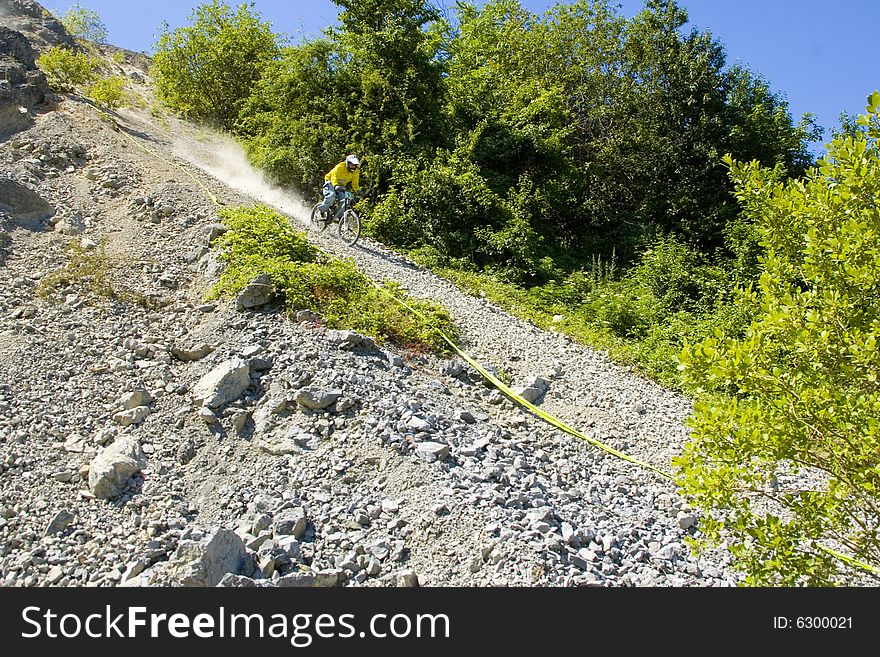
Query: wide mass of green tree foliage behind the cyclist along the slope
174 0 813 284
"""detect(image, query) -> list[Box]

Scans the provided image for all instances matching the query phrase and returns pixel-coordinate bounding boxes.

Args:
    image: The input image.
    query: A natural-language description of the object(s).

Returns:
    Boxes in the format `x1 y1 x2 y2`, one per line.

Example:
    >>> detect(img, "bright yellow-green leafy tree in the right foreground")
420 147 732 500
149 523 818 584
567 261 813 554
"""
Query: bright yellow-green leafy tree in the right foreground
680 91 880 585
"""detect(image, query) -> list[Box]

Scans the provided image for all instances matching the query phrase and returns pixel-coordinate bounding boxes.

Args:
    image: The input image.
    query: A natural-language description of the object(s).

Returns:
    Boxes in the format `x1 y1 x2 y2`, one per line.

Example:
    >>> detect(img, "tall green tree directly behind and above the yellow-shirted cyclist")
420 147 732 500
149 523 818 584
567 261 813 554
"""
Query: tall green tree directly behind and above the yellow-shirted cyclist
237 0 445 193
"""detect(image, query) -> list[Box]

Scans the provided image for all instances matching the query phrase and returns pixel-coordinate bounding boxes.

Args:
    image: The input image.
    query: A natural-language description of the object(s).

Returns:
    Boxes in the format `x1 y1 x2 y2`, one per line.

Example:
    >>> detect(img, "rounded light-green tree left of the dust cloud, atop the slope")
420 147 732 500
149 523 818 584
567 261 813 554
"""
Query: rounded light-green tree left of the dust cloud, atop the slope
153 0 278 129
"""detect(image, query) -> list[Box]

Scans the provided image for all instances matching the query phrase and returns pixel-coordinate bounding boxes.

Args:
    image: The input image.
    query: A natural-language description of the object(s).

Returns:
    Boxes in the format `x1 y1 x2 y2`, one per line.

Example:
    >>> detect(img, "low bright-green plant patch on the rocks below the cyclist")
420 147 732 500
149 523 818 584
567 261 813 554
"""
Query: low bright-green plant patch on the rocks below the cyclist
209 205 455 352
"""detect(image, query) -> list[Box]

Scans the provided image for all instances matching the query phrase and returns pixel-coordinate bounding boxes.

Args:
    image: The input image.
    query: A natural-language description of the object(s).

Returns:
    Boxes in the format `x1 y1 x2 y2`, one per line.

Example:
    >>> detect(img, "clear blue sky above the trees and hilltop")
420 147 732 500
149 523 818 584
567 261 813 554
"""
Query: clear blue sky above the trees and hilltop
42 0 880 147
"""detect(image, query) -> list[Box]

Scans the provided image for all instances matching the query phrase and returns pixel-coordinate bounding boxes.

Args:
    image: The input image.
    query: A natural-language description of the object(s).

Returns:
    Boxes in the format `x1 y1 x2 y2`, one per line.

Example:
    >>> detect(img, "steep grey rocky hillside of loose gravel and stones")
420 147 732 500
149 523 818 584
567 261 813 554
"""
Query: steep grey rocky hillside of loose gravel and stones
0 0 736 586
